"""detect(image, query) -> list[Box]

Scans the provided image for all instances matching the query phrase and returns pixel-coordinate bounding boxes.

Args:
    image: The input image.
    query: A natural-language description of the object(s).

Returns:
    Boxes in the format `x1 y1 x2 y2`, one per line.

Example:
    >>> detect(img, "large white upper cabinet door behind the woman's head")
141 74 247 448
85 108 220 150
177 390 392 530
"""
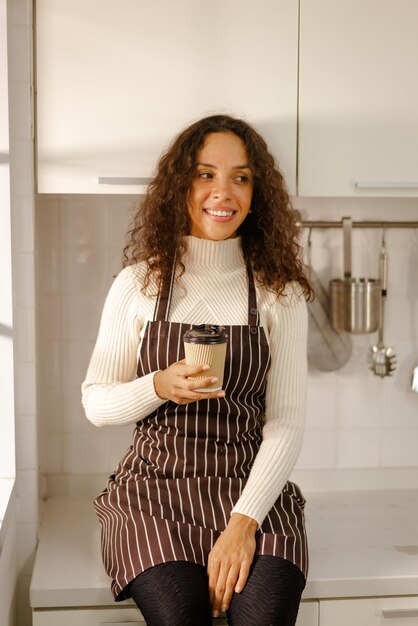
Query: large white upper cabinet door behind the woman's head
36 0 298 193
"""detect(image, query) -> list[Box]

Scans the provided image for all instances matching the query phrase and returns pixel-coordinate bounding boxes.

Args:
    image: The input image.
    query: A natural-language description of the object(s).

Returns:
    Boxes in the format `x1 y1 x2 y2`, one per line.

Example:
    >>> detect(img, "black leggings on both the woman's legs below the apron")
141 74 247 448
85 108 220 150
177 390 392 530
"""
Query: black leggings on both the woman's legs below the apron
129 556 305 626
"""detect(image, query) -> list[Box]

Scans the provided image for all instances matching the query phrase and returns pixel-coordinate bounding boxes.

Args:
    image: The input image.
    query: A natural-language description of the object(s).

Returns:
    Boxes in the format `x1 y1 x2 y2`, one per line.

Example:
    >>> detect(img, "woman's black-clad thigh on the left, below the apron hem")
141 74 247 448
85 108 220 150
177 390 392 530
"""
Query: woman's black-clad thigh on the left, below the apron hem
129 561 212 626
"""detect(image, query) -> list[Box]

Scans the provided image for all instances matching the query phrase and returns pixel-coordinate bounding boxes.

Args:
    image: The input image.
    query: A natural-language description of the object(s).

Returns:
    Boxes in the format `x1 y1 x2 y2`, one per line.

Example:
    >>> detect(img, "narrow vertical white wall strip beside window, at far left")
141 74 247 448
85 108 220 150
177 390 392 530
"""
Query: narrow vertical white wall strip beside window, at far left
5 0 38 626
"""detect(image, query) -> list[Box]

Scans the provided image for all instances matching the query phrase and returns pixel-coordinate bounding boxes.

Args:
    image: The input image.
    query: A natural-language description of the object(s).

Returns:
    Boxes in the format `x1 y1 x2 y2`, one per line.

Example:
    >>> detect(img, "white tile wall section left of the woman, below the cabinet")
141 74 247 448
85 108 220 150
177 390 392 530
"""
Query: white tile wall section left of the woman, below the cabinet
36 196 133 477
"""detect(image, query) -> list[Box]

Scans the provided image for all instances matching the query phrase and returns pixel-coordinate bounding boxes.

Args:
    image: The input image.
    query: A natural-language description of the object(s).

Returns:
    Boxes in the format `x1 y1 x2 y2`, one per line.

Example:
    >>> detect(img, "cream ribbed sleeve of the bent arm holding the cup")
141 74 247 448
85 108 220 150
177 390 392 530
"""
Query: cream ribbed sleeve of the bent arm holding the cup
82 267 164 426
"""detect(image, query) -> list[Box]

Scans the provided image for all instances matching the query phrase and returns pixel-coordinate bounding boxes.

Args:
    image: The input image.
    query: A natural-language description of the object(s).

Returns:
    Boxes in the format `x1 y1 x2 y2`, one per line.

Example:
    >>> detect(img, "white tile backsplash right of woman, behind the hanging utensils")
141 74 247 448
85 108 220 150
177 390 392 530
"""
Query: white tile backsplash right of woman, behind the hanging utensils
295 198 418 471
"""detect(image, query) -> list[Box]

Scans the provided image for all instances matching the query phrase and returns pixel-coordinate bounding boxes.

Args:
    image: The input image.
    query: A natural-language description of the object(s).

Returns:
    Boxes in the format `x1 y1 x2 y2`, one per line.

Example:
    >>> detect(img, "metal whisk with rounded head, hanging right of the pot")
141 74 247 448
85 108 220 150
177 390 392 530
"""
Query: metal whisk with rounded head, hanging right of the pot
369 228 396 378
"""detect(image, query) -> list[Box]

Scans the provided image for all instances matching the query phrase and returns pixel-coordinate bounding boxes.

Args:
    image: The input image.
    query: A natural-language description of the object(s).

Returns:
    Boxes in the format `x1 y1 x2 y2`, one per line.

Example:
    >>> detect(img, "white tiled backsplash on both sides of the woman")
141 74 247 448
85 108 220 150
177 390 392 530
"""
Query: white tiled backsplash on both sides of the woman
36 196 418 488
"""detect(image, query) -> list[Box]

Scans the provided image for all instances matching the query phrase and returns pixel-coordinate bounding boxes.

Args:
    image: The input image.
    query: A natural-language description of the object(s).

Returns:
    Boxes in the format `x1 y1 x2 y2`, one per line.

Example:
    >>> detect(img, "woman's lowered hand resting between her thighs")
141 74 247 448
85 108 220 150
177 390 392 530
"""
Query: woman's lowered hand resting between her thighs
207 513 258 617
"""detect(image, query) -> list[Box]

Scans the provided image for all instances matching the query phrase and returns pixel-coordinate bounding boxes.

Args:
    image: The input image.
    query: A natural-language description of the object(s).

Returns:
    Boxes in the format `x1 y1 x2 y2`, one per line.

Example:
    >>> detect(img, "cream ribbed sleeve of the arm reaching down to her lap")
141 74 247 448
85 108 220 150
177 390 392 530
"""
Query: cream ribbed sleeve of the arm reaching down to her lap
232 294 307 525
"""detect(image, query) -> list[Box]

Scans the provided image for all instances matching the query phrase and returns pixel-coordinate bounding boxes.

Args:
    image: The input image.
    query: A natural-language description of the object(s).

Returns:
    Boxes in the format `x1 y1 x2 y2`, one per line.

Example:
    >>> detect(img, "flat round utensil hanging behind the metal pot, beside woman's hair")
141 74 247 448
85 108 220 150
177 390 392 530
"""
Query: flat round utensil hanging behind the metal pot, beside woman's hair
307 228 351 372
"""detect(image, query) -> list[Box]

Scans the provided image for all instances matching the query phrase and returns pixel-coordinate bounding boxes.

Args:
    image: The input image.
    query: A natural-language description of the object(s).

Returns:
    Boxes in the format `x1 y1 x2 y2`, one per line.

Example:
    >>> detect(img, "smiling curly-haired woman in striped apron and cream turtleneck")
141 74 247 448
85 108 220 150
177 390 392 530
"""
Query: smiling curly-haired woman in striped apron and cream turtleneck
83 115 310 626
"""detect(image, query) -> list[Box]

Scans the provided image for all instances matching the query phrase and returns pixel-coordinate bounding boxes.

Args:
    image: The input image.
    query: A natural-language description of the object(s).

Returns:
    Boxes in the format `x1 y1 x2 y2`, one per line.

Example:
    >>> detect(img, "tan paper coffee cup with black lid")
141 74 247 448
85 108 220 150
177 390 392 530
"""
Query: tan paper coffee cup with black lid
183 324 228 392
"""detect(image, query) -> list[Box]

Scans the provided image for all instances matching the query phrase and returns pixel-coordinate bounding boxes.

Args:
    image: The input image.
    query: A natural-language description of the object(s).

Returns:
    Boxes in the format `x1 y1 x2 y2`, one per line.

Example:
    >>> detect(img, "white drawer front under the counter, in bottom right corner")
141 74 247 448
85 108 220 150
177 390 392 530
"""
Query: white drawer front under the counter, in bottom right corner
320 596 418 626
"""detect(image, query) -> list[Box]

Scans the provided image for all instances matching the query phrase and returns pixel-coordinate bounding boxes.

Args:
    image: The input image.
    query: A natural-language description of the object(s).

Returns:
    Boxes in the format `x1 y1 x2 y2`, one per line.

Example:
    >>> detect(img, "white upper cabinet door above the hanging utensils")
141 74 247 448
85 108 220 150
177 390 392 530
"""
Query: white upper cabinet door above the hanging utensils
298 0 418 196
